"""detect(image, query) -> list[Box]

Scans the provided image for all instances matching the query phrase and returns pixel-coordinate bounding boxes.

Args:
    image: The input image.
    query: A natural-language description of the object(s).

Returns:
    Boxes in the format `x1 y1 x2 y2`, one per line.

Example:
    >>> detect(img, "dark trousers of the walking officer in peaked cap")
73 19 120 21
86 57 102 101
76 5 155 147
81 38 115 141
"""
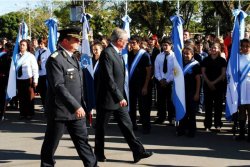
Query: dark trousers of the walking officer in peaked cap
41 118 97 167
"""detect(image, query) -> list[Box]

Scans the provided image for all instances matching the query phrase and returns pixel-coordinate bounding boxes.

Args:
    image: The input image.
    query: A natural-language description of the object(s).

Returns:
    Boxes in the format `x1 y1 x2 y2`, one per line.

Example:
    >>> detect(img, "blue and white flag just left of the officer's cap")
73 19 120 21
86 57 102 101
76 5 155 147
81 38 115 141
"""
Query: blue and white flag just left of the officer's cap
45 18 58 53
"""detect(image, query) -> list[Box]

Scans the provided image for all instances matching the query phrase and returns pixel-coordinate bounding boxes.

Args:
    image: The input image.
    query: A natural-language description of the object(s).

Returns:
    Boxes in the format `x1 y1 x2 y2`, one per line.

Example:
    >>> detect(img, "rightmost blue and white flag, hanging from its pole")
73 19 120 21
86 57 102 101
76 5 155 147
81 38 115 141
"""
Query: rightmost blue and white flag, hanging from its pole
226 9 247 120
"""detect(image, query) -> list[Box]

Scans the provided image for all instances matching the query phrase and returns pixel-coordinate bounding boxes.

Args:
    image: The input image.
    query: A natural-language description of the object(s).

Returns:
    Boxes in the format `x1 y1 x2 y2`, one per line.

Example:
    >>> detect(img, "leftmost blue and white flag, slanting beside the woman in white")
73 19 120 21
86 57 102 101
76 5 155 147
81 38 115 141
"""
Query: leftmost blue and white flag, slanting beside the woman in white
6 21 28 100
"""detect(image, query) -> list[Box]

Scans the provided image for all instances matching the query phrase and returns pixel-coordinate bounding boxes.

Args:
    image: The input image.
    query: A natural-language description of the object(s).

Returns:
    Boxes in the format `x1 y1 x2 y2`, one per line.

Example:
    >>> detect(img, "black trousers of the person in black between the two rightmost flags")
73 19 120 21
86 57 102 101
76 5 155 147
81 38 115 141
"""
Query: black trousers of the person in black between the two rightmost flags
204 88 223 129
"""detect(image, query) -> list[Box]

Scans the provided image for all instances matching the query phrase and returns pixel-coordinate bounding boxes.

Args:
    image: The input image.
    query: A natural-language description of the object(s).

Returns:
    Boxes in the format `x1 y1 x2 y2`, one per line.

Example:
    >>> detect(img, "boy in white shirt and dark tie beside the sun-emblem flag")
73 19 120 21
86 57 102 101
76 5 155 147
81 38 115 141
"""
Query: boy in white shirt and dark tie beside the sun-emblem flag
154 37 175 125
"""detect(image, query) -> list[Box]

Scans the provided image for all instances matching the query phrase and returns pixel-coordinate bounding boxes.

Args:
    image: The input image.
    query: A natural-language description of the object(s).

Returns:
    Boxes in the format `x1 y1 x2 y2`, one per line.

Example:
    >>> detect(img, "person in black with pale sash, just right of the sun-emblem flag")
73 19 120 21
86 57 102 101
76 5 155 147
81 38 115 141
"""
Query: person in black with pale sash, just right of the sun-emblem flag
177 46 201 137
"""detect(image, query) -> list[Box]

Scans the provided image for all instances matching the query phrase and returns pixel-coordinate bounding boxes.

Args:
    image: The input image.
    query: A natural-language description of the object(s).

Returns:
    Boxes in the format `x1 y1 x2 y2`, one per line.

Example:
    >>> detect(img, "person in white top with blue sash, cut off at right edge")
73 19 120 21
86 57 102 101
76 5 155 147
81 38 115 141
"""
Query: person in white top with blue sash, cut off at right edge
236 38 250 142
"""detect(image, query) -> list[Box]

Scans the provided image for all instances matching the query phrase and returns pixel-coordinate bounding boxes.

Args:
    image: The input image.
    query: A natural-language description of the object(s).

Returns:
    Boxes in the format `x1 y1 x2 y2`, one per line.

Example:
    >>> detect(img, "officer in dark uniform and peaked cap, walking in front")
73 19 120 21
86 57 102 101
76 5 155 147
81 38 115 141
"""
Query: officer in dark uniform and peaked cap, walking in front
41 27 97 167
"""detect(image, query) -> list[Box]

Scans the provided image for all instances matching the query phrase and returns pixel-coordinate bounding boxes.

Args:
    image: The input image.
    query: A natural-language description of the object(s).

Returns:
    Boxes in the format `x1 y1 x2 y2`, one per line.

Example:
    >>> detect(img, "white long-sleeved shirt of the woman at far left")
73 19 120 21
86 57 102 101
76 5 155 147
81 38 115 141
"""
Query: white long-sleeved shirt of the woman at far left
17 52 39 83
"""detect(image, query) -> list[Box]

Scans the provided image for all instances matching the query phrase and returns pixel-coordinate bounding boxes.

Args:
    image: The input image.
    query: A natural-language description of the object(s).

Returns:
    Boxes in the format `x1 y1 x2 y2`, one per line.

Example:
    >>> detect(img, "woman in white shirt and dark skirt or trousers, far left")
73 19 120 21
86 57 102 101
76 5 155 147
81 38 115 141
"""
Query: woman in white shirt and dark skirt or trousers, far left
16 39 39 119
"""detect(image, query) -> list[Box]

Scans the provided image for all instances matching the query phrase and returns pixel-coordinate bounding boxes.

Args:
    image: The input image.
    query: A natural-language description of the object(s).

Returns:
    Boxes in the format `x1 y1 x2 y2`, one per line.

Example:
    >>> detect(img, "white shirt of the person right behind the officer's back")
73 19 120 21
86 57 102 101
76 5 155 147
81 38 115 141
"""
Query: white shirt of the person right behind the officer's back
35 48 51 76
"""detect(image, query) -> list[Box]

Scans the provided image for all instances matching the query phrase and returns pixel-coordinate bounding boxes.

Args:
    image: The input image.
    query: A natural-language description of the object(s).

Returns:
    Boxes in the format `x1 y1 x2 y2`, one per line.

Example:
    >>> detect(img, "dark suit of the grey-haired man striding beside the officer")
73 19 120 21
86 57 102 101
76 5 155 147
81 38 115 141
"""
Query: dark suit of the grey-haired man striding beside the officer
95 45 145 159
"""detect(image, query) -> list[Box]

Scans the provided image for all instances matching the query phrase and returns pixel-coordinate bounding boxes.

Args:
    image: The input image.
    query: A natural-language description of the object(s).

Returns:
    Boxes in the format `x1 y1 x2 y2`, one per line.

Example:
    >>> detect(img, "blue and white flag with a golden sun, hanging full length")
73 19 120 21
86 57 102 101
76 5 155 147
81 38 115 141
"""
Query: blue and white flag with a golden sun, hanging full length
170 15 186 121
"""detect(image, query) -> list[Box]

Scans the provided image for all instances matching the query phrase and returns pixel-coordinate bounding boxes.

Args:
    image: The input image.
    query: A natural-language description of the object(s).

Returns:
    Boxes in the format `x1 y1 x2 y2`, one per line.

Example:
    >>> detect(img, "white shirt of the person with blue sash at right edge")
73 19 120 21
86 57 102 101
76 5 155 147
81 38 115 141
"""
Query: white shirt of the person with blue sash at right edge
240 54 250 104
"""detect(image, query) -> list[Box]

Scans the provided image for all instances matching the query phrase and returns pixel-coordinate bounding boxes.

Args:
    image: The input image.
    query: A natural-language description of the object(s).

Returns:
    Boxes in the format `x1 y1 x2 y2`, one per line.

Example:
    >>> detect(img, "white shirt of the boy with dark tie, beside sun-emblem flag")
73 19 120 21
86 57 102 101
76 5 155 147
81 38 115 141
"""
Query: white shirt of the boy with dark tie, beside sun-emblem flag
155 51 175 82
